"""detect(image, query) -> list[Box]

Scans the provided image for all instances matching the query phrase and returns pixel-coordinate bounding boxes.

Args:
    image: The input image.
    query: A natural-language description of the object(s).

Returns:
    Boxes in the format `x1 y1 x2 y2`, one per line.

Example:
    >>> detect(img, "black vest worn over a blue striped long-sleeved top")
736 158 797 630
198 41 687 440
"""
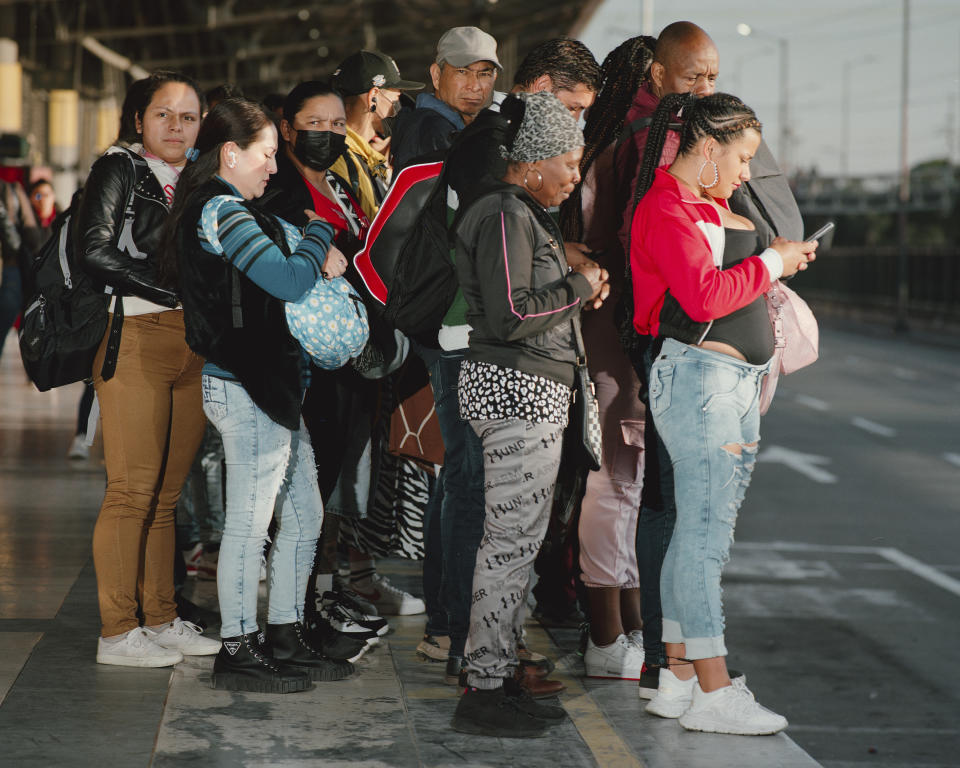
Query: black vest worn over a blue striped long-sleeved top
177 179 302 430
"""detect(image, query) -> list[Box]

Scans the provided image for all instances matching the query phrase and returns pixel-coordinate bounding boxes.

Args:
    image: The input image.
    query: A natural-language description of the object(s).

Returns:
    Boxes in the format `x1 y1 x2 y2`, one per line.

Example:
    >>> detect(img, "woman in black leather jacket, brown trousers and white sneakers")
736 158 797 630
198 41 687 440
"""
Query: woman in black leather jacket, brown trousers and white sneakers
76 73 219 667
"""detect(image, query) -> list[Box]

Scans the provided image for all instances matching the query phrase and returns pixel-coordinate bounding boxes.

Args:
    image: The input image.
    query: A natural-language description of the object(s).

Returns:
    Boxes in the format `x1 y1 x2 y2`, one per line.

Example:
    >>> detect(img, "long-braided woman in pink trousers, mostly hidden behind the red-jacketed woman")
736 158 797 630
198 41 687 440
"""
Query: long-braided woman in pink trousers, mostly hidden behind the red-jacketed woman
561 37 656 687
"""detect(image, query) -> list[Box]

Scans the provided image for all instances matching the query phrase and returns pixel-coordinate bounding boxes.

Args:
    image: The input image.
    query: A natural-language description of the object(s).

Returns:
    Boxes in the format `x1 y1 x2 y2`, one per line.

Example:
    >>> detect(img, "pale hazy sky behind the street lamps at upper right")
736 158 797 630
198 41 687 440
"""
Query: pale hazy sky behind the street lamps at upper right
580 0 960 176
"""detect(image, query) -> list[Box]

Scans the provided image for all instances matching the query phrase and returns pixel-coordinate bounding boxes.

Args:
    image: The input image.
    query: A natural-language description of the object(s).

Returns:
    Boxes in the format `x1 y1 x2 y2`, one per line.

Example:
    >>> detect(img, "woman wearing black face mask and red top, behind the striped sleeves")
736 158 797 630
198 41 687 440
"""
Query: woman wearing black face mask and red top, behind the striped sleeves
260 81 392 661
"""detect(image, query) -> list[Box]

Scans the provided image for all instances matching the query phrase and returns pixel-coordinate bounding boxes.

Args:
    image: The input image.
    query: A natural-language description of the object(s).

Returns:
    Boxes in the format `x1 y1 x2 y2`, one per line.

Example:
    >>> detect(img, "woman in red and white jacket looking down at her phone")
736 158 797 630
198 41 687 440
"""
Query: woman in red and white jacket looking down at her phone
630 93 817 735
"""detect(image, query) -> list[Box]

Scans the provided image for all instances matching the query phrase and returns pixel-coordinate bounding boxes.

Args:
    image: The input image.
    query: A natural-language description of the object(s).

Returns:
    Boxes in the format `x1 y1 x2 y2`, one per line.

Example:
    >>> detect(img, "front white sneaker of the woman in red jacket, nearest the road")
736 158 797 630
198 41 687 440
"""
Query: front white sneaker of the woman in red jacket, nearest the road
676 672 787 736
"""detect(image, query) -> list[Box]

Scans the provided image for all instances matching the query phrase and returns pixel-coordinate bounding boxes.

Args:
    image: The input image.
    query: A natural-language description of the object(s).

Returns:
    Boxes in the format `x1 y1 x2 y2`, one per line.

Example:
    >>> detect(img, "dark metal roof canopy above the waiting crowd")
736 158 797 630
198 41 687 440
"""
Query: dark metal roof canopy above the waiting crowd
0 0 601 98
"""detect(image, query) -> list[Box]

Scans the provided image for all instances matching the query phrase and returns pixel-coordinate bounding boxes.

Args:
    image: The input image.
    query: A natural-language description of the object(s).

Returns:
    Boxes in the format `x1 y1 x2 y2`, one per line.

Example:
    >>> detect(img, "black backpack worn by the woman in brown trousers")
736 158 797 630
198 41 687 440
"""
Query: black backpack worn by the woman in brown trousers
20 153 137 392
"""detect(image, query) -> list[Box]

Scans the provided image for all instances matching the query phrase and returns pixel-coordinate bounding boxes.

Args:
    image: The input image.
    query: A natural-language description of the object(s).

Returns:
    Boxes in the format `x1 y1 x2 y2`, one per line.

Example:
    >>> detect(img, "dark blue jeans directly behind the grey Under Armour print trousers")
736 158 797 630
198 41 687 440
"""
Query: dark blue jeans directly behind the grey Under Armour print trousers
423 352 484 656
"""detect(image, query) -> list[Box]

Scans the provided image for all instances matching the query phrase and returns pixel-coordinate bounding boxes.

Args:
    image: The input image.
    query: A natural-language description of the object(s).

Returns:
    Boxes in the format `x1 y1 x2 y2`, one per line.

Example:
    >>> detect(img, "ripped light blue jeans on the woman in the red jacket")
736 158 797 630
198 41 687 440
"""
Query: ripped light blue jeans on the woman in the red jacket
650 339 770 659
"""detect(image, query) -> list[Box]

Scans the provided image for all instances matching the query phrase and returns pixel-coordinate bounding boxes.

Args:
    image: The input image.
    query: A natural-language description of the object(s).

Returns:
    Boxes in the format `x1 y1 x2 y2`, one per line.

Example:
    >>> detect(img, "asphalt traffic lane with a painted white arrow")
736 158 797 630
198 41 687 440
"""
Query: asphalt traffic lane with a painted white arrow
737 390 960 566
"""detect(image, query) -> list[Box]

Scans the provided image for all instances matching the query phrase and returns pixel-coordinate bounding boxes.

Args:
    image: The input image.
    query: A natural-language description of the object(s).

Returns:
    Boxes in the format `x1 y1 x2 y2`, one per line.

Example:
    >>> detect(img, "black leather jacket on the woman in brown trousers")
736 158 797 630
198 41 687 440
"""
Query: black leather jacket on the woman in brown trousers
75 150 177 307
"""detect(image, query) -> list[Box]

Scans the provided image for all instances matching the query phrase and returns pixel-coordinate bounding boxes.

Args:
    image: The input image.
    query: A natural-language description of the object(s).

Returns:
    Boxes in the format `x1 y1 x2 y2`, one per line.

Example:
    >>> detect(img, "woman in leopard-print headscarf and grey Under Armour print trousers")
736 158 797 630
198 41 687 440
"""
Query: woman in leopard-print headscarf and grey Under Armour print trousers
452 92 608 737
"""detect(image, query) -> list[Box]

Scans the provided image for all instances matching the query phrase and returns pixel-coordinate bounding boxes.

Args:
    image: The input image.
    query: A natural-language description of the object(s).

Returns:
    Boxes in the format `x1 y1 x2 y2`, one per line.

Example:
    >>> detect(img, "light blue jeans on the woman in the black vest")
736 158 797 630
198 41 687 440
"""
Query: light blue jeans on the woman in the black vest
203 375 323 637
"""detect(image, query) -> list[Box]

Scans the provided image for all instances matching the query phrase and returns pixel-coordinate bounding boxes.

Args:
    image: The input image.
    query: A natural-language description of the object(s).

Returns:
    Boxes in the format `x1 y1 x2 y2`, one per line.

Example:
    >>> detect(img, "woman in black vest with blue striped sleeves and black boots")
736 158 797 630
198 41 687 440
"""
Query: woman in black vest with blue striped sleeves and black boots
165 99 353 693
